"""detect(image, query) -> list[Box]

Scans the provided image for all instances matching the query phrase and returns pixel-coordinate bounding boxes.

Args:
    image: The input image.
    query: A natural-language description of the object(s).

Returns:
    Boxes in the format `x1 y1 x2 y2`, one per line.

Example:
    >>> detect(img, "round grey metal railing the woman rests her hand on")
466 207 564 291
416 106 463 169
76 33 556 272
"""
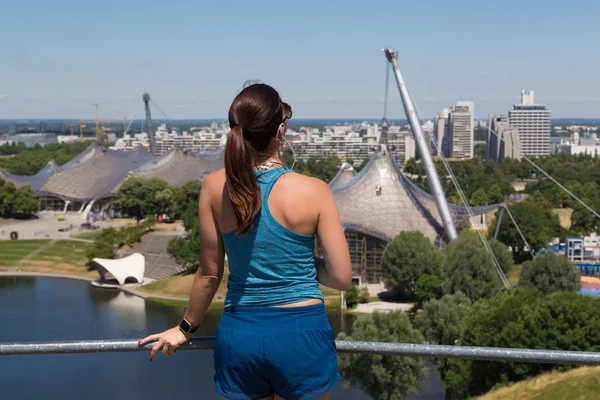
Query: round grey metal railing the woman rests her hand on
0 337 600 365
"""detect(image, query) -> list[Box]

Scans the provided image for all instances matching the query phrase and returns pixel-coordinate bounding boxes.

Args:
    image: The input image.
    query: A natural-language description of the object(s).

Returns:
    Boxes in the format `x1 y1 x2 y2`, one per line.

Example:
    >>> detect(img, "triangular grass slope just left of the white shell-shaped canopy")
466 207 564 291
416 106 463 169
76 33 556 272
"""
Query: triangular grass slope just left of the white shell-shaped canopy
19 240 98 278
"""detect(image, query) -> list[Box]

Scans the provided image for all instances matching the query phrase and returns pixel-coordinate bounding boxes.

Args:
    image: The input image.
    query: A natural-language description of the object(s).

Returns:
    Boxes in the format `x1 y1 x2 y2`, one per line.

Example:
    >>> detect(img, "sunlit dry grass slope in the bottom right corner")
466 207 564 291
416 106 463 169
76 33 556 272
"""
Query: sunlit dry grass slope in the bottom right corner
478 367 600 400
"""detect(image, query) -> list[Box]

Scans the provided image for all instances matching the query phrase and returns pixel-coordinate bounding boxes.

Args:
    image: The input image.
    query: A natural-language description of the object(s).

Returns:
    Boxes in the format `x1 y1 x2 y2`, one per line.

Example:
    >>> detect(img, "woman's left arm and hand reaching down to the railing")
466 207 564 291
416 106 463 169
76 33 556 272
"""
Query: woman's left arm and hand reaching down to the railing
139 174 225 361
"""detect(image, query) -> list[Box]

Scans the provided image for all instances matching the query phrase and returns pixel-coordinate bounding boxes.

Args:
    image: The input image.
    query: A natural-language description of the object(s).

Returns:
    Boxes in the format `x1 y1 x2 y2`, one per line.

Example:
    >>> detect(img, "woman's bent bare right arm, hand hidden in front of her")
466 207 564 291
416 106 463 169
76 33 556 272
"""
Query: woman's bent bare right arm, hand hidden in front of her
315 181 352 291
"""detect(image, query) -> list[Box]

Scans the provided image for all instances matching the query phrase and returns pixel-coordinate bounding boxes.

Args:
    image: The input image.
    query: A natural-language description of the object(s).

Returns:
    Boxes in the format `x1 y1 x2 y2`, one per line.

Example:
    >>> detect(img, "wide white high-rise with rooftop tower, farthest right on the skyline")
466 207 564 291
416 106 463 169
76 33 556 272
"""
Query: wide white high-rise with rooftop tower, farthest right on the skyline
508 90 551 156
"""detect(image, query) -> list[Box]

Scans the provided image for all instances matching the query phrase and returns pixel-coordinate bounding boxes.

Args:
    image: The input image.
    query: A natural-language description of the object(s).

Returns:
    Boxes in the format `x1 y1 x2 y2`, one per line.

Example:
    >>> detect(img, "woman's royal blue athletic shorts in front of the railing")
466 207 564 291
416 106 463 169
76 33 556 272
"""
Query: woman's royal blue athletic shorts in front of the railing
214 304 339 400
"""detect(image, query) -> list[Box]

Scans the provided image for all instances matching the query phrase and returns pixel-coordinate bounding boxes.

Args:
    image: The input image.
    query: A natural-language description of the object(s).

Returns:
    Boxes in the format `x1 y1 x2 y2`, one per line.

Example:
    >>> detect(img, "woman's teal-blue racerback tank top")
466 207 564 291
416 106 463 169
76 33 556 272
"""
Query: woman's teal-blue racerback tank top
221 167 323 308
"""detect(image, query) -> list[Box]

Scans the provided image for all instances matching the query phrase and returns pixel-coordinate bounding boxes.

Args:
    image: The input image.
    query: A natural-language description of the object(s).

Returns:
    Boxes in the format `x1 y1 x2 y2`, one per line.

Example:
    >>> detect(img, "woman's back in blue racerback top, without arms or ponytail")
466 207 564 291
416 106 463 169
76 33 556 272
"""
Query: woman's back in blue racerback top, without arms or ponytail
217 166 323 308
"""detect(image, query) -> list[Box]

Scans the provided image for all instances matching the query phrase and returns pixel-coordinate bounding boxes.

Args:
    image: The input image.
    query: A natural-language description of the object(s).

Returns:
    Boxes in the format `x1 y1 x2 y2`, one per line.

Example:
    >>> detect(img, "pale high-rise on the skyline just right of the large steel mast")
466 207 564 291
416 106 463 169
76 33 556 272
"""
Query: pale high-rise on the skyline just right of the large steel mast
434 101 475 159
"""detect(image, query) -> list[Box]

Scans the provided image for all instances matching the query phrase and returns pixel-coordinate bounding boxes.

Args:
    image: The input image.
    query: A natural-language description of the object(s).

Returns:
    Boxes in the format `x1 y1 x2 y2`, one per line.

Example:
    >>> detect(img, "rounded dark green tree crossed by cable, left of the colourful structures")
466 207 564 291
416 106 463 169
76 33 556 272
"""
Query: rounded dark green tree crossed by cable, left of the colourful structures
489 202 562 260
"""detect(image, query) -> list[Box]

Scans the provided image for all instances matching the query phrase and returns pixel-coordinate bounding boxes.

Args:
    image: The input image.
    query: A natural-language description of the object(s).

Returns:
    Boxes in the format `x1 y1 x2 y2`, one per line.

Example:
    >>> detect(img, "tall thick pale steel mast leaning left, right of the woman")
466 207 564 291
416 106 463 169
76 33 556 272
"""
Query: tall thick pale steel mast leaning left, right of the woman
383 48 458 240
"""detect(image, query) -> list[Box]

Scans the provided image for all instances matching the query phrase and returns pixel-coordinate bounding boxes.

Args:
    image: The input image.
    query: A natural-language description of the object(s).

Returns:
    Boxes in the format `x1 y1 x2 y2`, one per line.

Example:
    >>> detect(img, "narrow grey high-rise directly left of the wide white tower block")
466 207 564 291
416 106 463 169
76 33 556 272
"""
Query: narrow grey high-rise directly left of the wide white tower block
486 114 521 164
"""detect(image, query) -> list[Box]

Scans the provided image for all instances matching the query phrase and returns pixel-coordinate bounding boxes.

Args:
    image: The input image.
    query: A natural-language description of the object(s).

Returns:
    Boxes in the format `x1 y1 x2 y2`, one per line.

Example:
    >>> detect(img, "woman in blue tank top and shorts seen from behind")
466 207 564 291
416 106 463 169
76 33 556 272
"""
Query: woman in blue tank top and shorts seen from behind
142 84 351 400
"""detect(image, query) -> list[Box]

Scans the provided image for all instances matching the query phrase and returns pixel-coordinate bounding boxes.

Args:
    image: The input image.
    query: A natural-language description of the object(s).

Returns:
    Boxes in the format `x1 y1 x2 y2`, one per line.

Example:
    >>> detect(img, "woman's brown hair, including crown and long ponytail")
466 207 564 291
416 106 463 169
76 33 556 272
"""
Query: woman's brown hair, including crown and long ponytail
225 83 289 235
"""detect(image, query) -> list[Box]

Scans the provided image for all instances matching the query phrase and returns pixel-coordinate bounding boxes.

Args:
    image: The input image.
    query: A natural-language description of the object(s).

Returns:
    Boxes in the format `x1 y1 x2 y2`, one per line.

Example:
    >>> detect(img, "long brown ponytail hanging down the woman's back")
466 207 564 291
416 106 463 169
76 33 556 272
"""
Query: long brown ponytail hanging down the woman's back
225 125 261 235
